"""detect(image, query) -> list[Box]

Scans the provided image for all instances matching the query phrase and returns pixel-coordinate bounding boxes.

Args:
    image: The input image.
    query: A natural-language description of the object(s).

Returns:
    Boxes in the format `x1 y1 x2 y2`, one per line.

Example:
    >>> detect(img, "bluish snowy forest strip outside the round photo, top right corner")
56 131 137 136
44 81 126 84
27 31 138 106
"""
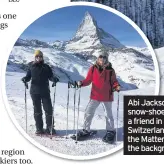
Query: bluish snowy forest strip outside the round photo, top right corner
72 0 164 48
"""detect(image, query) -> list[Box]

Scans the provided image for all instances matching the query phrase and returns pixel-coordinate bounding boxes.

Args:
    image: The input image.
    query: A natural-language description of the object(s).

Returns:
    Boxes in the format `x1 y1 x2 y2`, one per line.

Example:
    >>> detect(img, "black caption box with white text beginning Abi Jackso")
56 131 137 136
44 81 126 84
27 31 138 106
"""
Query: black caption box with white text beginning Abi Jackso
124 96 164 155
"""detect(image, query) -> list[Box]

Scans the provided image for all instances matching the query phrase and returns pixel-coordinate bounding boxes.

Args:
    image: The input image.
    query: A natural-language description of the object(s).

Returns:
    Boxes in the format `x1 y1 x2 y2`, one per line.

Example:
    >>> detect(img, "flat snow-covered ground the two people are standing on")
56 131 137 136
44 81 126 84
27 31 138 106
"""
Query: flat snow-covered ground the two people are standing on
6 72 153 156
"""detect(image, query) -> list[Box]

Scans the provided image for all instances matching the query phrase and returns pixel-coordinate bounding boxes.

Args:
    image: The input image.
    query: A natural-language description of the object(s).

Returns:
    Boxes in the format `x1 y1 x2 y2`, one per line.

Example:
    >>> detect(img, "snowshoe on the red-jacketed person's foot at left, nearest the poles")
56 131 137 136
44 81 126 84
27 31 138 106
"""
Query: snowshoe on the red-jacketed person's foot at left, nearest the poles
71 129 97 141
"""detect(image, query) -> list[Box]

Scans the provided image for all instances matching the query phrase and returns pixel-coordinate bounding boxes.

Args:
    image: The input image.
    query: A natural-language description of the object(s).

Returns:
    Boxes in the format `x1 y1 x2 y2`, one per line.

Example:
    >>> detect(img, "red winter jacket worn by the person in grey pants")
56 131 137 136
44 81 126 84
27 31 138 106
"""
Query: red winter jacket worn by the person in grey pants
82 64 119 101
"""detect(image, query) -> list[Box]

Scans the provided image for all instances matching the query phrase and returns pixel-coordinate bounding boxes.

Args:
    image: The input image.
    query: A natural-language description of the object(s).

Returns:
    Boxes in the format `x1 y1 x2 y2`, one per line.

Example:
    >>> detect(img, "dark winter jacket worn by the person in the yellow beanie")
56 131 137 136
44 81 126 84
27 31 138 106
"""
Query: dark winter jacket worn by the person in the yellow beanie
24 62 55 94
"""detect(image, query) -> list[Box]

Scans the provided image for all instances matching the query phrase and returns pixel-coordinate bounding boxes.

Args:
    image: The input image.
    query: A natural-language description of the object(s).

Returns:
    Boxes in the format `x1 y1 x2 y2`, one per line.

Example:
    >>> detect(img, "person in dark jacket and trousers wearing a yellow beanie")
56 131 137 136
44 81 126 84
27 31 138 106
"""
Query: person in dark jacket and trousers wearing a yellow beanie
22 50 59 135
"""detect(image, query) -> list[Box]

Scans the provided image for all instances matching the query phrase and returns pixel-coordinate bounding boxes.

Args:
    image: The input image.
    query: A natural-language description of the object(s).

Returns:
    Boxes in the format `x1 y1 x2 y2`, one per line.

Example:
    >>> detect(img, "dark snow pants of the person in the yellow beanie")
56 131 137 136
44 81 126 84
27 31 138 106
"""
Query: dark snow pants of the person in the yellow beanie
31 94 54 129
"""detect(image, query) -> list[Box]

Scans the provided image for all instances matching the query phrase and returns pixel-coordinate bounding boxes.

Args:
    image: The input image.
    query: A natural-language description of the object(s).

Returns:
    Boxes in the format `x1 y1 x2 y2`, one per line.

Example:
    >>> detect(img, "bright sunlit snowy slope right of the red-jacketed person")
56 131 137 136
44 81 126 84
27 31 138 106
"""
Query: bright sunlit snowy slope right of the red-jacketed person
108 48 155 88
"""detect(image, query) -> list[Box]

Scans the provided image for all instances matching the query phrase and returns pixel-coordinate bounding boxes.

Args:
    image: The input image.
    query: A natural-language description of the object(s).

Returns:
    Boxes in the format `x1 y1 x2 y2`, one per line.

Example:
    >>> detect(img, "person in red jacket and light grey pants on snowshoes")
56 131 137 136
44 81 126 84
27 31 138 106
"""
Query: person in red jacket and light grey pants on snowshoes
78 55 120 142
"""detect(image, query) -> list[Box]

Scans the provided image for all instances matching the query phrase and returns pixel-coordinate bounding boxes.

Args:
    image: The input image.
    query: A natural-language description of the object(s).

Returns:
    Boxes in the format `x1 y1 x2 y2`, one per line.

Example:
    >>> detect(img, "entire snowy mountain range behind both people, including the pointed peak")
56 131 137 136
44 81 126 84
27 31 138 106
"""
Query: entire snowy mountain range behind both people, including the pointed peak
10 12 155 90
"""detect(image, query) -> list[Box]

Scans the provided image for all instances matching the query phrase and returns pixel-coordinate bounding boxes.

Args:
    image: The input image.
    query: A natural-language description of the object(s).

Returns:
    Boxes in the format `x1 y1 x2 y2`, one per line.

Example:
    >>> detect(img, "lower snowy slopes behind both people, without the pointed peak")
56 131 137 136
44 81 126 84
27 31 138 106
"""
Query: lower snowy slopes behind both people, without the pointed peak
7 46 155 90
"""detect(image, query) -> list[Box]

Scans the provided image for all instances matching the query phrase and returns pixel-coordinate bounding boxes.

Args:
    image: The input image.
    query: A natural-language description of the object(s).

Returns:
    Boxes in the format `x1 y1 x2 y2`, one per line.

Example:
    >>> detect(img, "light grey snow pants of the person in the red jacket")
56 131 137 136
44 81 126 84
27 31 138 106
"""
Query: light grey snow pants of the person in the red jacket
83 99 114 131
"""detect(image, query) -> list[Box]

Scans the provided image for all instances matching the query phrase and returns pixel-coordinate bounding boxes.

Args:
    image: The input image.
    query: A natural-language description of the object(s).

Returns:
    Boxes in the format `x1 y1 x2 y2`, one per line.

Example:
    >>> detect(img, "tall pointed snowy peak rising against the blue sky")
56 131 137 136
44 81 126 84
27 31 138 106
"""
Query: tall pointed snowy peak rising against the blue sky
65 12 125 52
